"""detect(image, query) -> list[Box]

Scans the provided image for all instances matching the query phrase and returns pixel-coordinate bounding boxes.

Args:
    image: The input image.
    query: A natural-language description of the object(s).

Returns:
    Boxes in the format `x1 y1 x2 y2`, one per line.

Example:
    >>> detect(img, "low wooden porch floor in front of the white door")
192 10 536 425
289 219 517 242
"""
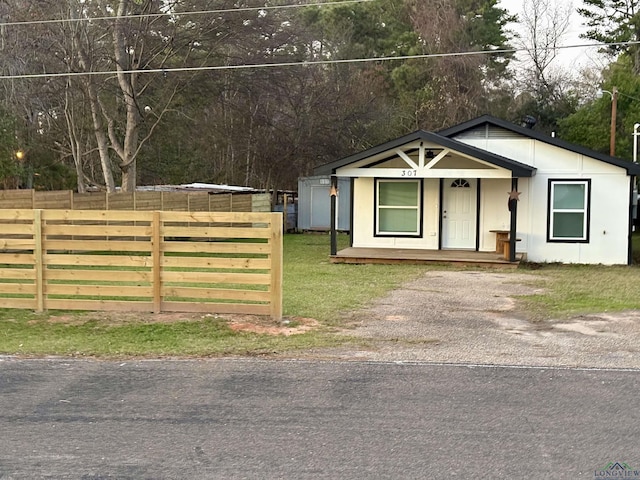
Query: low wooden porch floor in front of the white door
331 247 523 268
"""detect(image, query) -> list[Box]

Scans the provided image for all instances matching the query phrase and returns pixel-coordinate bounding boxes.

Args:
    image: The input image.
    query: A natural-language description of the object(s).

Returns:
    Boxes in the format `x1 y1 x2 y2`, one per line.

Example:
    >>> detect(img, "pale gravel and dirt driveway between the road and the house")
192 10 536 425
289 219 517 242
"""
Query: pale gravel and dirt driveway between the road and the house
304 271 640 368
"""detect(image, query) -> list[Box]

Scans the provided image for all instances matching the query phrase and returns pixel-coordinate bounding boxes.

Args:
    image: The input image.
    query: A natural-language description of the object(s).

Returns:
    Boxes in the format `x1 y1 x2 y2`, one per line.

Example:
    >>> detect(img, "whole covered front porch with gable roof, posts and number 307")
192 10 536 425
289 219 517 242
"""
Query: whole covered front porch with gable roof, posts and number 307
316 127 535 267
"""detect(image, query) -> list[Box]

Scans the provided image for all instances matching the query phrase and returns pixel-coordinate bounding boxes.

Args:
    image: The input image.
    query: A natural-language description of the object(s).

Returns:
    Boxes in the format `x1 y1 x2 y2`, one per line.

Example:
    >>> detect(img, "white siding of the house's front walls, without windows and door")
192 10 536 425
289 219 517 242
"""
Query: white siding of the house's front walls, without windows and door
342 125 629 264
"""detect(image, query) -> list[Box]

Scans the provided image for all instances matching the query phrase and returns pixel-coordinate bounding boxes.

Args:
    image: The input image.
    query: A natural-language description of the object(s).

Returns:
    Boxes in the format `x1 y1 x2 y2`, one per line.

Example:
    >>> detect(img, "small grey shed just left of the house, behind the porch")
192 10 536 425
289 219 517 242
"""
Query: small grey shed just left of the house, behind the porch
298 175 351 232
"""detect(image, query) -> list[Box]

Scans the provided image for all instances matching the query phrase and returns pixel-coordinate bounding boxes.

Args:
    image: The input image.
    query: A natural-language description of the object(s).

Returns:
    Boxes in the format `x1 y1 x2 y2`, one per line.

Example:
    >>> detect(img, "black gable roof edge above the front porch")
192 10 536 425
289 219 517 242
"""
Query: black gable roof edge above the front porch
313 130 536 177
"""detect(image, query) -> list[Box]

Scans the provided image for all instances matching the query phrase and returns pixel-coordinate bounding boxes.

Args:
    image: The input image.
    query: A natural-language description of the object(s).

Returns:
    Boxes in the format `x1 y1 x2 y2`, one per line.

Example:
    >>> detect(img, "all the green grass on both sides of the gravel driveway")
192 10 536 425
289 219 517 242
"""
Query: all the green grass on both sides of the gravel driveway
0 234 640 358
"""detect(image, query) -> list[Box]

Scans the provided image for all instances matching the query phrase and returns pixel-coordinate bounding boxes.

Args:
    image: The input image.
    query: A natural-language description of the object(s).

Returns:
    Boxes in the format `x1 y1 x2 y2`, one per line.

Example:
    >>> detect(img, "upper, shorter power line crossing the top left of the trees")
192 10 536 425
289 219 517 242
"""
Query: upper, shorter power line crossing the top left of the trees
0 0 375 27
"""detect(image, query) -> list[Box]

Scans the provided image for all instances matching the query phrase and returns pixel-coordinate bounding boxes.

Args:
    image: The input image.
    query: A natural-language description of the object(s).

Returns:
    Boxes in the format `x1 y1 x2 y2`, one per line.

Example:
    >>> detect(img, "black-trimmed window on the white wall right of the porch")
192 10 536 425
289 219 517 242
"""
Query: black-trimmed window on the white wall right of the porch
547 180 591 243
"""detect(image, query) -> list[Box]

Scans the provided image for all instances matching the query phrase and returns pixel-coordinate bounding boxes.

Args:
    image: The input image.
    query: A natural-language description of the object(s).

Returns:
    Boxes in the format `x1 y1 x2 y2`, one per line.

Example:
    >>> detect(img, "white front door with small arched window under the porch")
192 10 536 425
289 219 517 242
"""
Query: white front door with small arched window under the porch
442 178 478 250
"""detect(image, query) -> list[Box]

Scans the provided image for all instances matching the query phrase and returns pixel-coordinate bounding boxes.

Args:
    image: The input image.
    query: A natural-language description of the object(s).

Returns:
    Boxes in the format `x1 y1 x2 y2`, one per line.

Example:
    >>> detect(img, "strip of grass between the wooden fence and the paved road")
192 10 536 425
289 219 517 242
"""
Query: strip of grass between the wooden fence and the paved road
0 311 350 357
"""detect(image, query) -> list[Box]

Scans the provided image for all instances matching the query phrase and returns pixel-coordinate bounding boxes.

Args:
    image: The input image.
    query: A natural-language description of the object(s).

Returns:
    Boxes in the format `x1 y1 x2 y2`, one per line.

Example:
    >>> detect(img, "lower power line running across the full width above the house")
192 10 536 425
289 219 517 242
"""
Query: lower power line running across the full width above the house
0 41 640 80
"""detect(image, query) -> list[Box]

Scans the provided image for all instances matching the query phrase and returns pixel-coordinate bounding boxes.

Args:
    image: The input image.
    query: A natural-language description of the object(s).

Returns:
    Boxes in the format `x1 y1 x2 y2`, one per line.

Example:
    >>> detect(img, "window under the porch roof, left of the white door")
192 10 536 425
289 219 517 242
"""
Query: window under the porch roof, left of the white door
375 180 422 236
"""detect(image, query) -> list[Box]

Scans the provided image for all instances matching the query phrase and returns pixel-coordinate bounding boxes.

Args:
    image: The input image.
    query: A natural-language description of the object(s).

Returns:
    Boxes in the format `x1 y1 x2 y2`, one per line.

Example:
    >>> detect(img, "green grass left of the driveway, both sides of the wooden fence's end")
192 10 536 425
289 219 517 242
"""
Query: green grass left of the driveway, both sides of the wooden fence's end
0 235 425 357
